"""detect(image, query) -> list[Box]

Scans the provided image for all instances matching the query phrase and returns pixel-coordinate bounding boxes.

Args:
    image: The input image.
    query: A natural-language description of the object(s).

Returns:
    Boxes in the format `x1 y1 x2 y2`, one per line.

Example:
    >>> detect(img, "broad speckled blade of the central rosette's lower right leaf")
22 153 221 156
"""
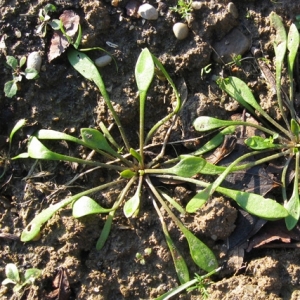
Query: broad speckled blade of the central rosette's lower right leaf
180 227 218 272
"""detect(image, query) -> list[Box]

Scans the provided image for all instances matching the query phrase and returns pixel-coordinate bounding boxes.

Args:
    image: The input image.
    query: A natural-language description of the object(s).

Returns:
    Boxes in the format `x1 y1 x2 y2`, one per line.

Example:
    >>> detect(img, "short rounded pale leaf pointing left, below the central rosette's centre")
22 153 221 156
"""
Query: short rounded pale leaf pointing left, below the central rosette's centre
72 196 114 218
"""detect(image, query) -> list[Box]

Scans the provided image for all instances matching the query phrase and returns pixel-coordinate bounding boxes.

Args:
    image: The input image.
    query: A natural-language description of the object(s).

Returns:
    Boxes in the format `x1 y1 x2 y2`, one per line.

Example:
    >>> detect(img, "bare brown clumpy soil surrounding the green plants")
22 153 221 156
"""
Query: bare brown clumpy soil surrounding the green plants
0 0 300 300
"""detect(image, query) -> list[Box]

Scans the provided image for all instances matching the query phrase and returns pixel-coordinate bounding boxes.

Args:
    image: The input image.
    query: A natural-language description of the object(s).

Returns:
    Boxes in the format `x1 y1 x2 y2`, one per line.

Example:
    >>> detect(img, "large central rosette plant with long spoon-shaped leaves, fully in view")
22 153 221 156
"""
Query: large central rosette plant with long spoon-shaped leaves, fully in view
10 12 288 298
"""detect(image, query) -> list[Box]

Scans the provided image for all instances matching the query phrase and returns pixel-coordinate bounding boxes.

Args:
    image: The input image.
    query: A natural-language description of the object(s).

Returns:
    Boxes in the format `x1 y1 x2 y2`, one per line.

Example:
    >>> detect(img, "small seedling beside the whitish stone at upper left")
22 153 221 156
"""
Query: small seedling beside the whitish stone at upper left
4 55 38 98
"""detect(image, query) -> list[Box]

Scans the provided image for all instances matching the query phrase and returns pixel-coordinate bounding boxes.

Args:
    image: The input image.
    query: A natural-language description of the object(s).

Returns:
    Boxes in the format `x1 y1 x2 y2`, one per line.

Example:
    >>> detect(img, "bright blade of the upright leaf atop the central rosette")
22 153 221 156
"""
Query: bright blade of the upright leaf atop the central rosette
135 48 154 93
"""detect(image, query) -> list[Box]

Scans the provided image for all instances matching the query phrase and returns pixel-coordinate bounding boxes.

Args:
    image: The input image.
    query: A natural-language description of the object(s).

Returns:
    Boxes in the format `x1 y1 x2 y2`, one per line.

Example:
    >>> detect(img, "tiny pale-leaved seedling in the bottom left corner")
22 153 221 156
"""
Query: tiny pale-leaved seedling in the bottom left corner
2 264 42 297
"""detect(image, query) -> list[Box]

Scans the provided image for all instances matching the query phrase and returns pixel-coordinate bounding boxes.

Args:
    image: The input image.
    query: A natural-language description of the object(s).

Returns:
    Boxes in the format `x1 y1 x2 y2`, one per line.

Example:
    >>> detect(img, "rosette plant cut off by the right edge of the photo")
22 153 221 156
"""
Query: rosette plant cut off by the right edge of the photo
191 12 300 229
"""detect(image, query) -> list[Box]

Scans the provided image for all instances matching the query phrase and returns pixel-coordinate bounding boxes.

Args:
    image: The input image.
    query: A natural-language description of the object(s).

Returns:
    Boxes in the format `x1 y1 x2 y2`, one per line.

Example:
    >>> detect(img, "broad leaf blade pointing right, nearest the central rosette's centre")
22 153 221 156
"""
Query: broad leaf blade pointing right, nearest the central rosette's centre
164 156 206 177
